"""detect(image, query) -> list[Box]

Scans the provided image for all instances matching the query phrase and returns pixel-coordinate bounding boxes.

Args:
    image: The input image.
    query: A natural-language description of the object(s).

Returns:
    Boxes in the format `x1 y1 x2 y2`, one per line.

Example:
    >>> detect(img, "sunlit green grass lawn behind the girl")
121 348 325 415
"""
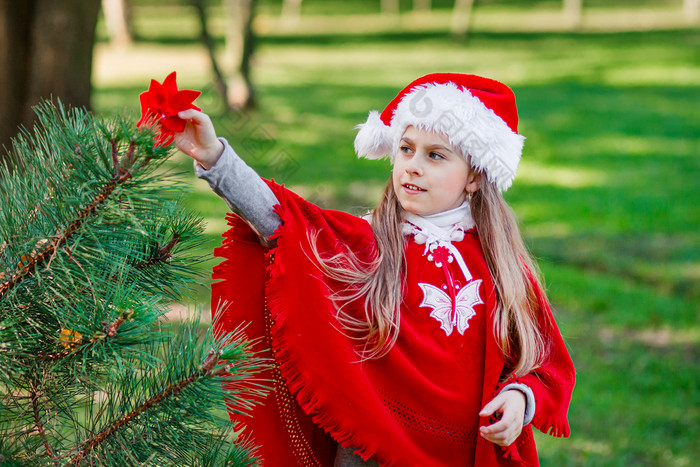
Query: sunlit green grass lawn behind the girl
95 2 700 466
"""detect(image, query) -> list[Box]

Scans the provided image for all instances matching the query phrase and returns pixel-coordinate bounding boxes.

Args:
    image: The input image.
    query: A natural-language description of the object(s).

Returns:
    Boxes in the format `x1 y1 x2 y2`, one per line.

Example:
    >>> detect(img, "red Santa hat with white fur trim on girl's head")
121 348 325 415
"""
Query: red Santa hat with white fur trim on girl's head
355 73 525 191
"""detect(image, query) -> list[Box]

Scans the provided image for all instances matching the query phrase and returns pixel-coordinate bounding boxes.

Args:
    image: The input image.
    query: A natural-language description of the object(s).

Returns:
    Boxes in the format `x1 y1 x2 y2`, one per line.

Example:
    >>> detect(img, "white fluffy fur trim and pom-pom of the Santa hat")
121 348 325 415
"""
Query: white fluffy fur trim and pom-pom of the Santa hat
355 82 525 191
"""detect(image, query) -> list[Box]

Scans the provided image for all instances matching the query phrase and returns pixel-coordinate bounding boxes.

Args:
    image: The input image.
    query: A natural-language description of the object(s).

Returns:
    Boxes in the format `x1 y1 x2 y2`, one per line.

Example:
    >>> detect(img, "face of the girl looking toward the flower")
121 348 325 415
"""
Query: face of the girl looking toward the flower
392 126 479 216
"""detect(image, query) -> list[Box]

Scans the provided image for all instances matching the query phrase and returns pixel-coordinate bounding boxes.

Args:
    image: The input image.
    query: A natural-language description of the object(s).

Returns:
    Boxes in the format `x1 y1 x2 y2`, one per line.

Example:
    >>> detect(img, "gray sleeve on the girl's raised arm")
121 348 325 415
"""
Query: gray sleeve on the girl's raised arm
194 138 282 245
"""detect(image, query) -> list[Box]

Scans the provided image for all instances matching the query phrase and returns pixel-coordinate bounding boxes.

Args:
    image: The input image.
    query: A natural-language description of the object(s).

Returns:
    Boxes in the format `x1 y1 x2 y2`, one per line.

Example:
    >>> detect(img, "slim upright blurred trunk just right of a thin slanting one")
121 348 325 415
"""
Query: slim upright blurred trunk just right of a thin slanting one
224 0 254 109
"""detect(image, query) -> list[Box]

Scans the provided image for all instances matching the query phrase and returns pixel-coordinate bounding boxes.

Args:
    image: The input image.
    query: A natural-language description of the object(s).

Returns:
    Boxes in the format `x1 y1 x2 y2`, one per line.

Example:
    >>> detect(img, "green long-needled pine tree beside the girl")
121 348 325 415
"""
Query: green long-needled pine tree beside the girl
0 104 254 466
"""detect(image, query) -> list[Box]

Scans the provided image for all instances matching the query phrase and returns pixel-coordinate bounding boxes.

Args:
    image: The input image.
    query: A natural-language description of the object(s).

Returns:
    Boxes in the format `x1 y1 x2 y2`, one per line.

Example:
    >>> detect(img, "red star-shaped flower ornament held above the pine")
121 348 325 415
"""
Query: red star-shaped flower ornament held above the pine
136 71 202 146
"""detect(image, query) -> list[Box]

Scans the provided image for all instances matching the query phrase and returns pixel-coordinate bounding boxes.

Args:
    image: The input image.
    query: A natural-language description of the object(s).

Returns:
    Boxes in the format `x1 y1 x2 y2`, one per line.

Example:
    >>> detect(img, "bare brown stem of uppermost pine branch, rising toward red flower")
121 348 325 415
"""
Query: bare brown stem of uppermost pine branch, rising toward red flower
0 140 150 298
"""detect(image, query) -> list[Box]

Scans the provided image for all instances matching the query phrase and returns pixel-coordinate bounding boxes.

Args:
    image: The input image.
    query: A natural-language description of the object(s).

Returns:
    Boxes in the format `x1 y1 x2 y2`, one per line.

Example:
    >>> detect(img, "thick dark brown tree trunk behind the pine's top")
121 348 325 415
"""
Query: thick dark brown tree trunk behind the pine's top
0 0 100 166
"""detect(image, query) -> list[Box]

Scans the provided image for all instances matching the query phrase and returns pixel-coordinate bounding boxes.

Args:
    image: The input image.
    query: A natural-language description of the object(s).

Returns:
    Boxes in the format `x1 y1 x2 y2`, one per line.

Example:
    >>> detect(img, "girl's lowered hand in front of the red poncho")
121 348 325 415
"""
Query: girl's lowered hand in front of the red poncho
479 390 527 446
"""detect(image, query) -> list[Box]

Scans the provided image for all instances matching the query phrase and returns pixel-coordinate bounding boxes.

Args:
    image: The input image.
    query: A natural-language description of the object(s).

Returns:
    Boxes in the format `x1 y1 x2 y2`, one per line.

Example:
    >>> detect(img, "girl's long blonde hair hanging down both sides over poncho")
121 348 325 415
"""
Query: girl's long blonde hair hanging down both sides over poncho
311 177 549 376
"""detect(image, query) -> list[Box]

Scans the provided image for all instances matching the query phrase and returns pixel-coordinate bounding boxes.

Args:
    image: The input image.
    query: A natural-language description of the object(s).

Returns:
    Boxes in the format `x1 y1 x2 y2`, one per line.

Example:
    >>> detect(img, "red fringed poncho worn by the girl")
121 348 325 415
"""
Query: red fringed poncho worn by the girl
212 183 574 467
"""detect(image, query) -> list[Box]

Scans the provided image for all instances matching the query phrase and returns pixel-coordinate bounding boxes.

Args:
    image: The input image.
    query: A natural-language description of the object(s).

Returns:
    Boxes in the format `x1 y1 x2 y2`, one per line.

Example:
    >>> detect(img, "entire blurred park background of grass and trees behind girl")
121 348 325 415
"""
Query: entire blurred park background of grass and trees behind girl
0 0 700 466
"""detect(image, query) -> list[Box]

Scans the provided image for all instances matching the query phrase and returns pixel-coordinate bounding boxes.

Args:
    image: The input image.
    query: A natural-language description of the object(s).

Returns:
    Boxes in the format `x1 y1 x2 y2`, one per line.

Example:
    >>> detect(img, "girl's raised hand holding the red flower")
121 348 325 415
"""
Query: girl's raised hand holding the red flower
175 109 224 170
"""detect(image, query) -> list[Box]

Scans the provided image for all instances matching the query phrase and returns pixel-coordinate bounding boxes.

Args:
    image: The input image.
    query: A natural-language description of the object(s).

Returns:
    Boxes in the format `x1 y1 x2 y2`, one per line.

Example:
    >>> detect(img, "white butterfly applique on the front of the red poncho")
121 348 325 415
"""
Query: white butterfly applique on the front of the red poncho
418 279 484 336
